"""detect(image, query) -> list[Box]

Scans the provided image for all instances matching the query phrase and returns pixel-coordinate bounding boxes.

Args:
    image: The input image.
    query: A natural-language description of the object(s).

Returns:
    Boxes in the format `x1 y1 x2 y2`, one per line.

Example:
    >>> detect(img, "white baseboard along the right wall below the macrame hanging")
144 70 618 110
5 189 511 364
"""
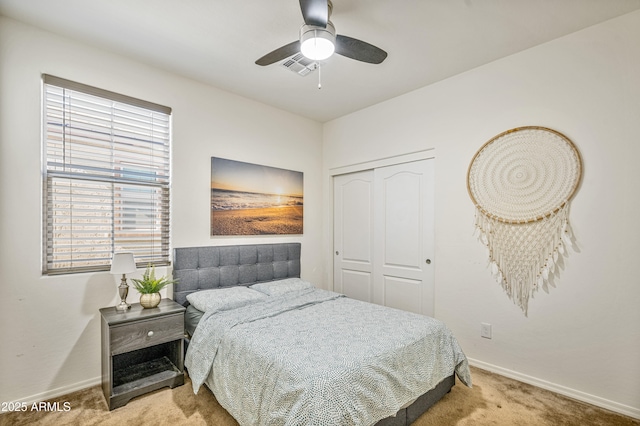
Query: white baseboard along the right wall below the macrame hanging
469 358 640 419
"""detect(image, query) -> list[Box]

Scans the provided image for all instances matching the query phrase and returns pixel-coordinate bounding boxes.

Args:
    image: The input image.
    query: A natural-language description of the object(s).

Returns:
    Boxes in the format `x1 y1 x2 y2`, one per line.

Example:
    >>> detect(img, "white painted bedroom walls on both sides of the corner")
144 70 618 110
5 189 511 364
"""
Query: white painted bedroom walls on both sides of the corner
0 7 640 417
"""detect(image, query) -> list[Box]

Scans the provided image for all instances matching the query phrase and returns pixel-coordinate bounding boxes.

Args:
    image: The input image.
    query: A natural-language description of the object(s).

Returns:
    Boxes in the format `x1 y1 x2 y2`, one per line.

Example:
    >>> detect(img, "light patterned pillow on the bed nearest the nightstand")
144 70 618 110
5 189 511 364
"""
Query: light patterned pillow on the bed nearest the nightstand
187 287 267 312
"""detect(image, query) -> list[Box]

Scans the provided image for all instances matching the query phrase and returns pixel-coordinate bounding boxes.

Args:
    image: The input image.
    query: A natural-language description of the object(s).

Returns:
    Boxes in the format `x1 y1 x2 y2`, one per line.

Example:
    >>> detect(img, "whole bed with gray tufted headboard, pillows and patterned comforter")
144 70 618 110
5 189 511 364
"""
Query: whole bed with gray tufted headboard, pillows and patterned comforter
173 243 471 426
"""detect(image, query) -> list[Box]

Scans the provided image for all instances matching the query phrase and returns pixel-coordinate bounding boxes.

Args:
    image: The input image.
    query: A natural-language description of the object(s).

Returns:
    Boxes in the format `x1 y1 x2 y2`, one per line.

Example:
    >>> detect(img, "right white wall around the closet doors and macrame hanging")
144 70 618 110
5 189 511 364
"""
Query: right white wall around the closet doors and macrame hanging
323 12 640 417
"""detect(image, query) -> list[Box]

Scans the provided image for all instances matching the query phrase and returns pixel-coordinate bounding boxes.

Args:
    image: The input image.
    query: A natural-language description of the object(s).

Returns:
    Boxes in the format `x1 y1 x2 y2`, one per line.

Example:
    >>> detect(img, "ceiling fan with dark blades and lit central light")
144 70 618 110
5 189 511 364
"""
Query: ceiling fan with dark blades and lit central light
256 0 387 66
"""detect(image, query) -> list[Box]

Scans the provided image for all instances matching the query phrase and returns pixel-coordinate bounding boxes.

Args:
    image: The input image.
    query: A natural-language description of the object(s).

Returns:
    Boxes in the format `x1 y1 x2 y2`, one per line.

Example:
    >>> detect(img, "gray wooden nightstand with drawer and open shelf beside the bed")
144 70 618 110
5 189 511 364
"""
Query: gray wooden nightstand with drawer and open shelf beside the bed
100 299 185 410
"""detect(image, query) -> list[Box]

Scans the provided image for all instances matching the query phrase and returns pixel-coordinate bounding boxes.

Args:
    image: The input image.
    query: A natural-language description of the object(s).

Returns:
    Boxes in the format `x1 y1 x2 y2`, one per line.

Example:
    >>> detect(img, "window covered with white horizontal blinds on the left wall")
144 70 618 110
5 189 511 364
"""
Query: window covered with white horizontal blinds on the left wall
43 75 171 274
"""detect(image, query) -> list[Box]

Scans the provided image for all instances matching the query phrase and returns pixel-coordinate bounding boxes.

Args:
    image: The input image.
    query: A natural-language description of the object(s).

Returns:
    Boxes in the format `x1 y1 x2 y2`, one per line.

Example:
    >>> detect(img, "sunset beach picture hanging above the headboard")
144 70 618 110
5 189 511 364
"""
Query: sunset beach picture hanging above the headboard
211 157 304 235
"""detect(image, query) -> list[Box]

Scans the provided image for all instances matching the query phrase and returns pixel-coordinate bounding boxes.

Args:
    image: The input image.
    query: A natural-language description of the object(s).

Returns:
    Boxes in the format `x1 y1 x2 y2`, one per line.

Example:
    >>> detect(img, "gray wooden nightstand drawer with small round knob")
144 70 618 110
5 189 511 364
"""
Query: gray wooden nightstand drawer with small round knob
110 314 184 355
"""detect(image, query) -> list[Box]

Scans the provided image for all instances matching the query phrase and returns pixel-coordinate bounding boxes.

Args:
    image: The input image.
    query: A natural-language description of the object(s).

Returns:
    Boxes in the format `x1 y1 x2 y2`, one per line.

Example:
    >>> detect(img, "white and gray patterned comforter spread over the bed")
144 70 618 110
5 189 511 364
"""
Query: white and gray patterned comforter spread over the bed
185 288 471 426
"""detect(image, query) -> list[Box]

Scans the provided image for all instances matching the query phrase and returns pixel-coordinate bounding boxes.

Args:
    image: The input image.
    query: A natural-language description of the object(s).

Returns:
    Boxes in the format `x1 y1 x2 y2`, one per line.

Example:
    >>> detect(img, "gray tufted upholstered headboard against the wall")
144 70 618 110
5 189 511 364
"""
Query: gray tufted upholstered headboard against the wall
173 243 301 305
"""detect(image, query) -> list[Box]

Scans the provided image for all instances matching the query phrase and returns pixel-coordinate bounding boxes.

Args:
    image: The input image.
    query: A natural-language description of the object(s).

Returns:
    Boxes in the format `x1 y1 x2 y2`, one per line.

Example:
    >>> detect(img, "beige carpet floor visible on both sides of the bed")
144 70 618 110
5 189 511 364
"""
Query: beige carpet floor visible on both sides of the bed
0 367 640 426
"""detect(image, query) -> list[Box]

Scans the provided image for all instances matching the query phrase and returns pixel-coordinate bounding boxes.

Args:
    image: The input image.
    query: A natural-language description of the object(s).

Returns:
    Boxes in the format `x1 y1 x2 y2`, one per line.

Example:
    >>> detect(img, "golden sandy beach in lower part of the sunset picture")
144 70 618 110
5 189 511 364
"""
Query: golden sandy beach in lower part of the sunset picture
211 206 303 235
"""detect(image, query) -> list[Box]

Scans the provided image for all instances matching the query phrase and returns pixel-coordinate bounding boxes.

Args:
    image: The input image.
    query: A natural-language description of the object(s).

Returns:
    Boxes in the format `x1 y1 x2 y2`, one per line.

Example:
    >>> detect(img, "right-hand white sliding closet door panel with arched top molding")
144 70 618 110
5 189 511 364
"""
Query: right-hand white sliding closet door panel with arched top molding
373 159 434 316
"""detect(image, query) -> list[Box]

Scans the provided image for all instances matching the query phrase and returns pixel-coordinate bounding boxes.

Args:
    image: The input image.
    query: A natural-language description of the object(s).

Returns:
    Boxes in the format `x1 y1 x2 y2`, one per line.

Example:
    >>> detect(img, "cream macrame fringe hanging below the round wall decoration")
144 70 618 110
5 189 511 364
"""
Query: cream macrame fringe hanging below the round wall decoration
475 202 572 316
